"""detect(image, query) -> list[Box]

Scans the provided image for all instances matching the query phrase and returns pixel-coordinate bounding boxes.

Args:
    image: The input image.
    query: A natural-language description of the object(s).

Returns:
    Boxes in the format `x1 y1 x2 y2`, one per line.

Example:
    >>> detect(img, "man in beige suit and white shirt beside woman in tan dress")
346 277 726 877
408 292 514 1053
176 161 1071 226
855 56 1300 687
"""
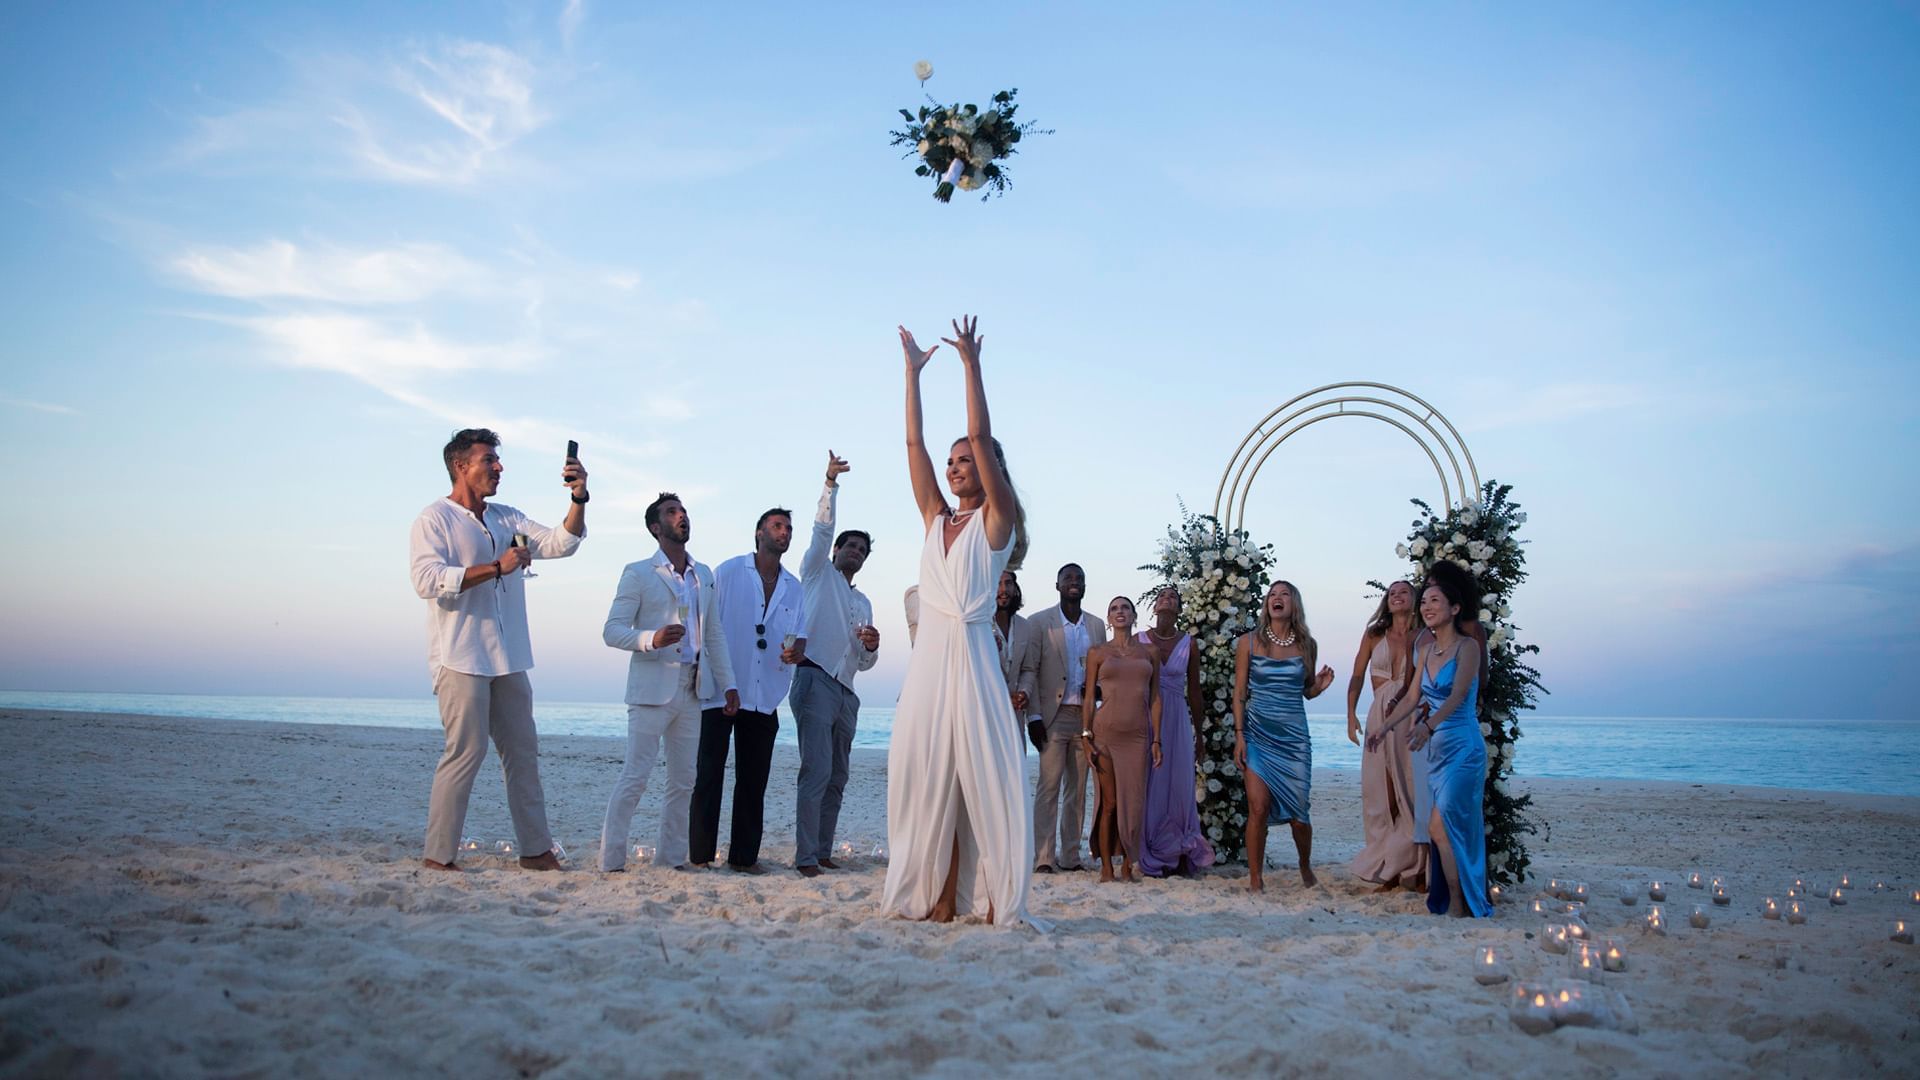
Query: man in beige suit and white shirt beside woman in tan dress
1027 563 1106 874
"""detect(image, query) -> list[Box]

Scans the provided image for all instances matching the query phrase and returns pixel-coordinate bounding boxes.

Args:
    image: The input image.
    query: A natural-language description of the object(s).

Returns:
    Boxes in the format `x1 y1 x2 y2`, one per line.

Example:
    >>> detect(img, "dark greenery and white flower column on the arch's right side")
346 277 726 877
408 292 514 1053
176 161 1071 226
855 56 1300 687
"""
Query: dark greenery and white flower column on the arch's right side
1371 480 1546 884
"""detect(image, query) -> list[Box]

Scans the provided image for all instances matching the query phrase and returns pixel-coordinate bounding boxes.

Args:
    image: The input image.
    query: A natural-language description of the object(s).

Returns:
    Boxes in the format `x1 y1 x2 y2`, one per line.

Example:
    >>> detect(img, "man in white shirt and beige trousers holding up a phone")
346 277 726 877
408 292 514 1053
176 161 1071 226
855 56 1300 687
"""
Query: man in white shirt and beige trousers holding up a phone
407 427 589 871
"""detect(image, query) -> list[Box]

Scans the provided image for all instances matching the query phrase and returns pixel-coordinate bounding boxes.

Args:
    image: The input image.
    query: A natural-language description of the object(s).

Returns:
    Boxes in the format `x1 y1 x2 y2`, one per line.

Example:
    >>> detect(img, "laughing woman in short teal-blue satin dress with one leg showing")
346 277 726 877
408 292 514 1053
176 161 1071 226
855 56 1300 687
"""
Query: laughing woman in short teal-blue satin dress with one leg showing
1233 580 1332 892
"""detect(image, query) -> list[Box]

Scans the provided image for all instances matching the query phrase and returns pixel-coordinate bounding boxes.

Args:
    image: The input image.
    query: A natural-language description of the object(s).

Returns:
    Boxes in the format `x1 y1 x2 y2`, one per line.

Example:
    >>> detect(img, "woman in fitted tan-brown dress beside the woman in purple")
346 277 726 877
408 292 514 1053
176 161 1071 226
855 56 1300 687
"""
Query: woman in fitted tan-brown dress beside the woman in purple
1081 596 1160 882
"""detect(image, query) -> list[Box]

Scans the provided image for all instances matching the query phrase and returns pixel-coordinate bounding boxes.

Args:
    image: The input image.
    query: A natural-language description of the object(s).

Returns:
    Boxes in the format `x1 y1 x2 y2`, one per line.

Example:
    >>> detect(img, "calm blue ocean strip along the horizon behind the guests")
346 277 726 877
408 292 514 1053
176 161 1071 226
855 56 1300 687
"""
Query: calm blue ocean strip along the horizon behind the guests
0 690 1920 796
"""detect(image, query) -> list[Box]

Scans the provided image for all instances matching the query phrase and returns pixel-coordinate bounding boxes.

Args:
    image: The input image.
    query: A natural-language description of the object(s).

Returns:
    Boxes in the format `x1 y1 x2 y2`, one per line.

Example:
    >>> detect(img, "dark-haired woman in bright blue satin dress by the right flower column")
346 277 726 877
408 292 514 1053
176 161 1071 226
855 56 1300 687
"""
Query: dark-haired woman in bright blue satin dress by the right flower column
1402 578 1494 919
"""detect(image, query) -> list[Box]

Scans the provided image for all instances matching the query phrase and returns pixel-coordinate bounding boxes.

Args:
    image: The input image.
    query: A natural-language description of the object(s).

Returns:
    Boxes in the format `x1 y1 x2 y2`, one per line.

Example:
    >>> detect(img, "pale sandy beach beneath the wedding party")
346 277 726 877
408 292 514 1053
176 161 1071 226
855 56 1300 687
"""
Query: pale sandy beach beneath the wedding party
0 709 1920 1078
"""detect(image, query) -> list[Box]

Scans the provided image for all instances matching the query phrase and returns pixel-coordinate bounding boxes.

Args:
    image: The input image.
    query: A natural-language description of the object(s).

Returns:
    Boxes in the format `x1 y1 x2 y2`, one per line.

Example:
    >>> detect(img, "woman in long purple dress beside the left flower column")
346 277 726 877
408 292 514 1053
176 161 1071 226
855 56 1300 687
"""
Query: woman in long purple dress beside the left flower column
1140 588 1213 878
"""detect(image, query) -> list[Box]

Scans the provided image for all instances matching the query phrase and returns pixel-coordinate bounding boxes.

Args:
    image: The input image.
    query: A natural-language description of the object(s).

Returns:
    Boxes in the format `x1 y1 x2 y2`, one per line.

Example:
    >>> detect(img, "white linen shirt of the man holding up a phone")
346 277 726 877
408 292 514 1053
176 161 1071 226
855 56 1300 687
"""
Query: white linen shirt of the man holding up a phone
407 498 582 676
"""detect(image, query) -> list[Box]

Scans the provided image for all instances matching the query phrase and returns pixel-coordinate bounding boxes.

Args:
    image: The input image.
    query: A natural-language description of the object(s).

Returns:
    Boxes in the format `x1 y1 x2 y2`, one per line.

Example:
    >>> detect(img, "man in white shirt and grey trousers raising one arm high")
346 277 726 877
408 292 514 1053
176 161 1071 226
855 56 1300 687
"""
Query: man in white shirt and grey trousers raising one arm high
793 450 879 878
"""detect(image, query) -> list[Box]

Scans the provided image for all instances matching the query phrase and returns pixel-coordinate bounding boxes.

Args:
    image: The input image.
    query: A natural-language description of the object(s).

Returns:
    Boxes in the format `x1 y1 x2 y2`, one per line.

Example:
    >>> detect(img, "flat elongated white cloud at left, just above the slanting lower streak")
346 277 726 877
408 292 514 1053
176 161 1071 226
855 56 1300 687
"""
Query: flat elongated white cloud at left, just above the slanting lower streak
171 240 488 304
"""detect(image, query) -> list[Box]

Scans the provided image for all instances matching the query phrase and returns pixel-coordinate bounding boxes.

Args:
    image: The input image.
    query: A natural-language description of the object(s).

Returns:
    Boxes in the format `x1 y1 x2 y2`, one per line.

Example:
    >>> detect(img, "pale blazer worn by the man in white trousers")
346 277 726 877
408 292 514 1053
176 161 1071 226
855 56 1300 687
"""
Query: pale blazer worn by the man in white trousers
601 552 737 705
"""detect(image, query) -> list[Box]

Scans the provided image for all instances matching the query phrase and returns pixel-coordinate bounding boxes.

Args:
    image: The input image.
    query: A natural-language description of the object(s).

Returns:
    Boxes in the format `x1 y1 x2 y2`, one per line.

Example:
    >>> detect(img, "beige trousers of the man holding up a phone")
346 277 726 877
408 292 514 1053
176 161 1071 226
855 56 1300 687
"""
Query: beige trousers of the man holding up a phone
426 667 553 863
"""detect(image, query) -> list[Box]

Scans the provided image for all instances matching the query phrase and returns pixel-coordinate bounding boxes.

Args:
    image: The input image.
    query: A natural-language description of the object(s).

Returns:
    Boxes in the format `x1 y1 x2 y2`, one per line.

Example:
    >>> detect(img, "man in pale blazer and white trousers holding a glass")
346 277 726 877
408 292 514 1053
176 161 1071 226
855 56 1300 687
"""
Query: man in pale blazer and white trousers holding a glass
601 492 739 872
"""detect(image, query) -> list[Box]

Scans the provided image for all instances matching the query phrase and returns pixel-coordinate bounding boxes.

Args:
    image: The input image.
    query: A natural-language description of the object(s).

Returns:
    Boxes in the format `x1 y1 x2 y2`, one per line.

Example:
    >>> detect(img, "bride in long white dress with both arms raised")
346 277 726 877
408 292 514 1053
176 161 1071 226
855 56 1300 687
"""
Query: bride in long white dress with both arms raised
881 319 1041 926
